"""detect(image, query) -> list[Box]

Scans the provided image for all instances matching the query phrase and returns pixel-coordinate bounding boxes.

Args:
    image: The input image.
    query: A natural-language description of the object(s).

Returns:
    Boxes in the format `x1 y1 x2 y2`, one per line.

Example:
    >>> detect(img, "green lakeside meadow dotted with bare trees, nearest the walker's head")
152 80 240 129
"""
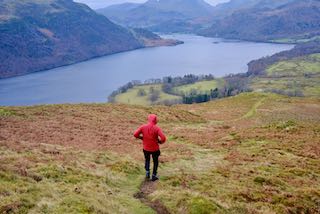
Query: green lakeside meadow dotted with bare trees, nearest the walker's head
115 84 181 105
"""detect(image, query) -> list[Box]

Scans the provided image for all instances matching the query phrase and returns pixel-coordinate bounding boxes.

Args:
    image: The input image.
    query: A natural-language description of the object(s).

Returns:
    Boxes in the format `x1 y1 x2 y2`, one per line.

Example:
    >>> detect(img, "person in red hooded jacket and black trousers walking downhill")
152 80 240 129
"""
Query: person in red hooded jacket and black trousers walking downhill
134 114 166 181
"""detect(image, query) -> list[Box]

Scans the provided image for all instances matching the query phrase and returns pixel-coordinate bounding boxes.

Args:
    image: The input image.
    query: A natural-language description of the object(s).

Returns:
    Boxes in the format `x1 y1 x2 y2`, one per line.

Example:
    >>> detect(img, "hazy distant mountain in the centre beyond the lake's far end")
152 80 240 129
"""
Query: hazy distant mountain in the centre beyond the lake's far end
97 0 213 31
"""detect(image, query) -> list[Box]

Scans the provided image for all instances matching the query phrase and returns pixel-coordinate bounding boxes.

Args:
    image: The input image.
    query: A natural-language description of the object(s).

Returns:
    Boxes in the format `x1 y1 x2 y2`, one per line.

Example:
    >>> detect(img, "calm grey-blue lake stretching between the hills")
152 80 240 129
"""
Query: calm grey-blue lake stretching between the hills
0 35 293 105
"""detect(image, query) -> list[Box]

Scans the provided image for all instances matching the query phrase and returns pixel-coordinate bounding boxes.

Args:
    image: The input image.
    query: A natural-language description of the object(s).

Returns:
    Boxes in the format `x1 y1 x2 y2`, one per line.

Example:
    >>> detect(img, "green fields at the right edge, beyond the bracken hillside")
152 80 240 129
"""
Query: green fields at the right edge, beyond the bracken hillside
250 54 320 97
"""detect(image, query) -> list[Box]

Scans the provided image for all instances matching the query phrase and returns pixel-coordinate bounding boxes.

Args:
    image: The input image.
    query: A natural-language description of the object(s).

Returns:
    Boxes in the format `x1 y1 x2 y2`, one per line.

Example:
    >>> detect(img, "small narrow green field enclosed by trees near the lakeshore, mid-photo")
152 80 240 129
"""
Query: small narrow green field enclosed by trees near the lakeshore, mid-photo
173 79 224 95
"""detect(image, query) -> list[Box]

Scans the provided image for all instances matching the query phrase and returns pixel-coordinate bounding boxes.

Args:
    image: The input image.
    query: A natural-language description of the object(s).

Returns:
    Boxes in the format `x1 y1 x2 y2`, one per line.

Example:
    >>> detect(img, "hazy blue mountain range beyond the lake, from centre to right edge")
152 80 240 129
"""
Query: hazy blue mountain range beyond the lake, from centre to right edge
98 0 320 42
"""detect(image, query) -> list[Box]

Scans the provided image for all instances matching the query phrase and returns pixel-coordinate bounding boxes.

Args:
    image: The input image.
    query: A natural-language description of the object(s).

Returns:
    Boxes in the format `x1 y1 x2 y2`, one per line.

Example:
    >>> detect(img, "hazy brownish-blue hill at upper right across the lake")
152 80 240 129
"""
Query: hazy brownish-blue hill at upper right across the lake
201 0 320 41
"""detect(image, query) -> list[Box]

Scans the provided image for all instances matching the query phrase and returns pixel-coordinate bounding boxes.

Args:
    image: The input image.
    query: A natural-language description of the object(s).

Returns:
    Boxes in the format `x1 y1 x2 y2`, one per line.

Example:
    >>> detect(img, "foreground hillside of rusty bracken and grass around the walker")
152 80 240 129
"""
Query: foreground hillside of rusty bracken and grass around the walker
0 93 320 213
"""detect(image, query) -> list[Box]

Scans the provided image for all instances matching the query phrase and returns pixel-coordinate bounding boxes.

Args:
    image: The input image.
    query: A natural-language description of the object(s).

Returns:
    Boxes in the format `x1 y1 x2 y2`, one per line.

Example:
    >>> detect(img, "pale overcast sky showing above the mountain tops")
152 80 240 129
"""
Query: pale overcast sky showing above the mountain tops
74 0 229 9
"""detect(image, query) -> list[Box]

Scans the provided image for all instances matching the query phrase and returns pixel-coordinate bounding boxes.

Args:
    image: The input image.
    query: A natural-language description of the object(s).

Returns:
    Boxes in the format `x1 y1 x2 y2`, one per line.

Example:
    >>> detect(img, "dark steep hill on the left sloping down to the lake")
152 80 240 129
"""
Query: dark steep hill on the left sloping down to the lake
0 0 180 78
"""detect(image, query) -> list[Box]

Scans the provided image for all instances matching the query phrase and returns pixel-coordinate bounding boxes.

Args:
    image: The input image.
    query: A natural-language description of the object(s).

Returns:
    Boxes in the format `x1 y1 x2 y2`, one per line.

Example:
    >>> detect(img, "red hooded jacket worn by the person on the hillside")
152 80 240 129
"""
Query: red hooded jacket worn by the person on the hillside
134 114 166 152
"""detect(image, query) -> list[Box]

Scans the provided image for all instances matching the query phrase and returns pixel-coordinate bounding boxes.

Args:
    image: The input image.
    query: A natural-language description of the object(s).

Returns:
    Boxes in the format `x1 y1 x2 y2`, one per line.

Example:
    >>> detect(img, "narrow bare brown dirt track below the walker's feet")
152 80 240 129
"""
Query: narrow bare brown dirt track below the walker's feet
134 180 170 214
